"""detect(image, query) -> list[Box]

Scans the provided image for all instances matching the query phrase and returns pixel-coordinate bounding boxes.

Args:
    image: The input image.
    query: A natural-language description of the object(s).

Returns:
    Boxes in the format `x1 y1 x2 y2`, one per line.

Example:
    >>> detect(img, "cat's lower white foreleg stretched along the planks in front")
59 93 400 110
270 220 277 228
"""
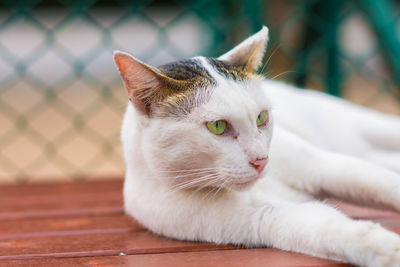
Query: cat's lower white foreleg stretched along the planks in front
155 191 400 267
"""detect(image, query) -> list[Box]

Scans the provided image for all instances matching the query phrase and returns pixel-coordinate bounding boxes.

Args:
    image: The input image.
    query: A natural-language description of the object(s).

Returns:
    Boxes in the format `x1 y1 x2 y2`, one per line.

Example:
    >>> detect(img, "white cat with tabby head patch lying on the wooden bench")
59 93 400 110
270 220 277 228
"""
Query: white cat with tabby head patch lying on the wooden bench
114 26 400 266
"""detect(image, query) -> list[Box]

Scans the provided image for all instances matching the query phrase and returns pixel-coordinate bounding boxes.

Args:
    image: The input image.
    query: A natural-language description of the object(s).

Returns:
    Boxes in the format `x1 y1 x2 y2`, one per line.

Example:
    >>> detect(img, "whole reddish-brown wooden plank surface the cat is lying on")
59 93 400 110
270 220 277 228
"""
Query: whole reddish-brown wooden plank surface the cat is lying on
0 181 400 267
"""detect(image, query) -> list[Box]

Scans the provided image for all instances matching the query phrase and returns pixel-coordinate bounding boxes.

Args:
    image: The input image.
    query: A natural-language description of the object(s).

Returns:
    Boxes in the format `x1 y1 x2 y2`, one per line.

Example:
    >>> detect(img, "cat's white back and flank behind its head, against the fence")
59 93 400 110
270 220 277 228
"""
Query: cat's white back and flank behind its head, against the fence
265 81 400 173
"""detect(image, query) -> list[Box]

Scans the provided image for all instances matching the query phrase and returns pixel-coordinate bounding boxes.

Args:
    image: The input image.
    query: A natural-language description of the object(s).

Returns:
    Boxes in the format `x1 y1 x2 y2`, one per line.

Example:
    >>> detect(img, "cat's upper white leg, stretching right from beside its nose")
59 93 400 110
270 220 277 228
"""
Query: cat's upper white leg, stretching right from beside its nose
270 128 400 211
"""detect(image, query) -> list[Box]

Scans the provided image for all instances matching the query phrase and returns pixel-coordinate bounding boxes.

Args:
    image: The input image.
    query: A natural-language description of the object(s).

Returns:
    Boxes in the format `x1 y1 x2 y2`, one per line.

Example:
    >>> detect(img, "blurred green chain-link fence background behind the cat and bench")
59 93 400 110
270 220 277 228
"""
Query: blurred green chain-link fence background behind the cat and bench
0 0 400 183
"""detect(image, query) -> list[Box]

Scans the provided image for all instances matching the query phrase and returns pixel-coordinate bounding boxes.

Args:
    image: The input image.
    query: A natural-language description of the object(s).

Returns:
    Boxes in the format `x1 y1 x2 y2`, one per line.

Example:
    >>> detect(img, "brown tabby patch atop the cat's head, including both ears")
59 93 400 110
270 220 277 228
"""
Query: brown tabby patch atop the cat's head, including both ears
114 26 268 117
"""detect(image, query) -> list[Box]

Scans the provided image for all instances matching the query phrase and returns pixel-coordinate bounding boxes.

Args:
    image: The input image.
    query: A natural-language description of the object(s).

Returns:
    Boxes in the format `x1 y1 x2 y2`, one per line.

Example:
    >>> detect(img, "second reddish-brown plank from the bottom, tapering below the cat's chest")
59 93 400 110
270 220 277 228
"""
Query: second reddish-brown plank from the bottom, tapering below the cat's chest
0 231 237 260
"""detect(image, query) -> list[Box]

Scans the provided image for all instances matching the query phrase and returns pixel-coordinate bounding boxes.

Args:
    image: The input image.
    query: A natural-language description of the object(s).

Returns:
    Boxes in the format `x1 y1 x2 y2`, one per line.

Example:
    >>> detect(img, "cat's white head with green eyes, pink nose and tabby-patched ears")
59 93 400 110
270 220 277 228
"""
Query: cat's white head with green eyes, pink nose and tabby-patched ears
114 26 272 190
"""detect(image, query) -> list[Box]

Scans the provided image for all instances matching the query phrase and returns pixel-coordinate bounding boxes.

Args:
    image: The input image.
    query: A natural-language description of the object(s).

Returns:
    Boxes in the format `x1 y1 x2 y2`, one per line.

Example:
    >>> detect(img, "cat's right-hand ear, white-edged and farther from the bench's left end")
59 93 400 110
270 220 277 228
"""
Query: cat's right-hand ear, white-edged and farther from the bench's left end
218 26 268 73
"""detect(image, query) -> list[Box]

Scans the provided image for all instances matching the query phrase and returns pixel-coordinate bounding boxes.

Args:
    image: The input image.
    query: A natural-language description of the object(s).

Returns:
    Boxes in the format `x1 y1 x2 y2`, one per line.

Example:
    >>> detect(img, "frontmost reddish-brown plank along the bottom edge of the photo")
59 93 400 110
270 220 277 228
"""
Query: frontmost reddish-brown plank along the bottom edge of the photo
0 249 349 267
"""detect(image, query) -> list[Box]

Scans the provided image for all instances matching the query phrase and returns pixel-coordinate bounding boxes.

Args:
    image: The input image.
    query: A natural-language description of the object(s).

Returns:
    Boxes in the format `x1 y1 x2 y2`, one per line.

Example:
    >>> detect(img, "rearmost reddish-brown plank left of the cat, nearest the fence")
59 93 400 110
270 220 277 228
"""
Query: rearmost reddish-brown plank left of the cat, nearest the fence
0 181 123 221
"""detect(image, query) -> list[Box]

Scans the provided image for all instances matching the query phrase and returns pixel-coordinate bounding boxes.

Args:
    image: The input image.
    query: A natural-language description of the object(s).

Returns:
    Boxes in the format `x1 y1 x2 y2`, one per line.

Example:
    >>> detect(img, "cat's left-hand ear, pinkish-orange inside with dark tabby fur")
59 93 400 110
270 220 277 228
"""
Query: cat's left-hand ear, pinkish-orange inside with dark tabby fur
114 51 184 115
